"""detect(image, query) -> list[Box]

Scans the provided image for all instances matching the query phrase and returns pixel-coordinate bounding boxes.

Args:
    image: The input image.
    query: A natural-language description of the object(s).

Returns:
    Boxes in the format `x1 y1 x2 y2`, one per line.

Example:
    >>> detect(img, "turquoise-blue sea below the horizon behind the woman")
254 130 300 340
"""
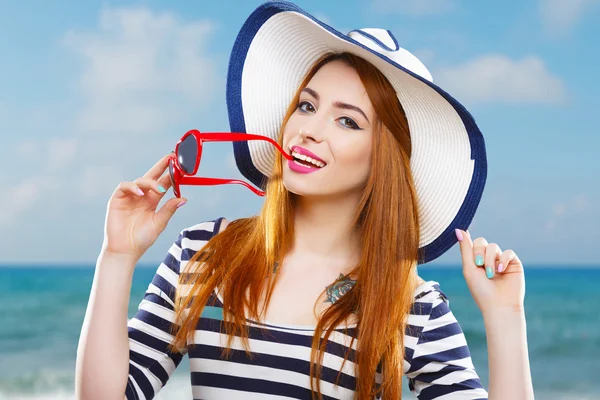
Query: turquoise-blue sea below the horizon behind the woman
0 265 600 400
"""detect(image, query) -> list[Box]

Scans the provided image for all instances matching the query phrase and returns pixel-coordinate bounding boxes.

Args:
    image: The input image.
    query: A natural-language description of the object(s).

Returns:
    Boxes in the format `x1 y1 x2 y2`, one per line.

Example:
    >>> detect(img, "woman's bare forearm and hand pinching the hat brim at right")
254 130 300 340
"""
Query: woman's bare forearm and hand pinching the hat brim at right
456 229 534 400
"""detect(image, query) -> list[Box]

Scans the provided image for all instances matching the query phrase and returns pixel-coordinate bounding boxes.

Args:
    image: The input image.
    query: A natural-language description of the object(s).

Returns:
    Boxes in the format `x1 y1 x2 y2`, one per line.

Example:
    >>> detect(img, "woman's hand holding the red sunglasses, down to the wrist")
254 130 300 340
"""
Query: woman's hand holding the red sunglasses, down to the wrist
102 153 186 261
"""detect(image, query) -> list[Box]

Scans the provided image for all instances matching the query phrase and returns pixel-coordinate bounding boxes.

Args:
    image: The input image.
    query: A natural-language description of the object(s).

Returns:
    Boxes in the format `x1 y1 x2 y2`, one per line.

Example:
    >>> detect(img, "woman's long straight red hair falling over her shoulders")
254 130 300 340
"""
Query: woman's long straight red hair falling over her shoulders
171 53 419 400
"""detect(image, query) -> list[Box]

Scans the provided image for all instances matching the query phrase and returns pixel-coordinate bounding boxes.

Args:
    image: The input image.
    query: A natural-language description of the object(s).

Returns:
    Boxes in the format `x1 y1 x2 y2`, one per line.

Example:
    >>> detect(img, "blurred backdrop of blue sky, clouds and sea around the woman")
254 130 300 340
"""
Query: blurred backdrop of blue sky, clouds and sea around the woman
0 0 600 400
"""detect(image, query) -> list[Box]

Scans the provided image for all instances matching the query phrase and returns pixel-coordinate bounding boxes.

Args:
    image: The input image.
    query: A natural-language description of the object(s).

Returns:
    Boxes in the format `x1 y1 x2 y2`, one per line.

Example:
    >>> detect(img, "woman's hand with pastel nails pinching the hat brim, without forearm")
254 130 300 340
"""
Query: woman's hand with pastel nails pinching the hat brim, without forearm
457 229 525 318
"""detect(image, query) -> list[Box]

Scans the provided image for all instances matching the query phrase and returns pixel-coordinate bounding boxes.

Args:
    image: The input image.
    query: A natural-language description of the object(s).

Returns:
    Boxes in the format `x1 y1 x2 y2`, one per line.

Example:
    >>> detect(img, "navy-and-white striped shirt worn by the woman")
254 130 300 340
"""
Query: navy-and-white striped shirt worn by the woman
125 218 487 400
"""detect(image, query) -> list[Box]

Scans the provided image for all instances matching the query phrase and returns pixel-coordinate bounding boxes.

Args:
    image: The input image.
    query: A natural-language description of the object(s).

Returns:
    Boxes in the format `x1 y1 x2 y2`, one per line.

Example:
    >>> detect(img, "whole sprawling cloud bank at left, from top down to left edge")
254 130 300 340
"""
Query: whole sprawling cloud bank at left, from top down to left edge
0 7 219 228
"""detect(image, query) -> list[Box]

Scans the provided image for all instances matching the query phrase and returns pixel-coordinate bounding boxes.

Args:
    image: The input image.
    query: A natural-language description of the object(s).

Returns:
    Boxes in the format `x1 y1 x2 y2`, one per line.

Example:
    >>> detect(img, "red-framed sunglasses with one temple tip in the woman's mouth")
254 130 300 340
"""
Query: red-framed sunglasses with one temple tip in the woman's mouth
169 129 293 197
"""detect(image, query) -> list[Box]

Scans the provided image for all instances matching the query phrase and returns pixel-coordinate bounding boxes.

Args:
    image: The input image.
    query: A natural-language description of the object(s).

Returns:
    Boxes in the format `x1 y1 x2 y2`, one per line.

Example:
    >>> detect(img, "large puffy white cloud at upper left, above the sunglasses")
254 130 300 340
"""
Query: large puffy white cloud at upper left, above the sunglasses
65 8 218 135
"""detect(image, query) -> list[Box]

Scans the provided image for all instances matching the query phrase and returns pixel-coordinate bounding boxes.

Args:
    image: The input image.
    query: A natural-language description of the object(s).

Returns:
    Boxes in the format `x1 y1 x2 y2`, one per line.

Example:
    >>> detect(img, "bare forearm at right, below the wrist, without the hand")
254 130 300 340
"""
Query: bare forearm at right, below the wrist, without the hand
483 307 533 399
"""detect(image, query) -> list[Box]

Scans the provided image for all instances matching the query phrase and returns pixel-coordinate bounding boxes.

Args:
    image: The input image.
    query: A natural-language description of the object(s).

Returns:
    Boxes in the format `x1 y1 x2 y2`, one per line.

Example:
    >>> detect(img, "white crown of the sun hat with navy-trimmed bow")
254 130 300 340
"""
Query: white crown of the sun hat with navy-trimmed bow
348 28 433 82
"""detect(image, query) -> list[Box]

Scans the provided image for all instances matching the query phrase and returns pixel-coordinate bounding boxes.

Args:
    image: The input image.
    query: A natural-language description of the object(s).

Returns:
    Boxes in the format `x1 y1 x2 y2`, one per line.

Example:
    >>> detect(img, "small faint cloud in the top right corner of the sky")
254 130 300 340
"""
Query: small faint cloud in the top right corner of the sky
539 0 600 35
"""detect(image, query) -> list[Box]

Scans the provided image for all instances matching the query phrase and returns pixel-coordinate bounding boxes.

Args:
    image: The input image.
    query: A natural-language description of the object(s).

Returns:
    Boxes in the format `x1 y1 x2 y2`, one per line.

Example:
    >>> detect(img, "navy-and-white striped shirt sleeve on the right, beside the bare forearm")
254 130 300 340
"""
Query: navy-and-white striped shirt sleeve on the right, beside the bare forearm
405 284 488 400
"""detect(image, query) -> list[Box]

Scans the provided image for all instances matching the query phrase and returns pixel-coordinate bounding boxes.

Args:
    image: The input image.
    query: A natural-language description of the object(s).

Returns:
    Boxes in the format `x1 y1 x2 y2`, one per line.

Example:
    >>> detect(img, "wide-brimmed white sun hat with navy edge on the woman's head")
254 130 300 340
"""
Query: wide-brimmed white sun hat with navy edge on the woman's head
226 1 487 264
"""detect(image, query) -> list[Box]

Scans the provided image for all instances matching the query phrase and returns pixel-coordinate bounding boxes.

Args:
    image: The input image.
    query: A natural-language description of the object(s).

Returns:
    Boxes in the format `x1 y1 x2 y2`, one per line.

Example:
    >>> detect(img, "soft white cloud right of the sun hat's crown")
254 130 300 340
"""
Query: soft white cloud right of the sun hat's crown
433 54 566 104
